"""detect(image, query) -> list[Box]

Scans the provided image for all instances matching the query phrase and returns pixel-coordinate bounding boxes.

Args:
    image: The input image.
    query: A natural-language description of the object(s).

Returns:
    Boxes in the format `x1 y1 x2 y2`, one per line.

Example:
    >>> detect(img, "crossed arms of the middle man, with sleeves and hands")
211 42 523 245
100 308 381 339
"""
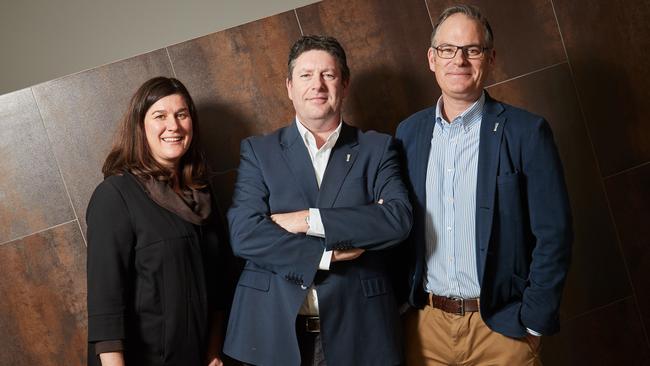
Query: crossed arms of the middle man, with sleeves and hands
228 139 412 283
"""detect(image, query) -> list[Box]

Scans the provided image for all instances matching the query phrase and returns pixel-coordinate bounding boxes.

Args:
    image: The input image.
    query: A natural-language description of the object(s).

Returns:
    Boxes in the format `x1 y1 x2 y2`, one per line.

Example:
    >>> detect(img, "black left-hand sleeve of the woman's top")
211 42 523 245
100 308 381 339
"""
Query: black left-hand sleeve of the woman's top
86 181 134 342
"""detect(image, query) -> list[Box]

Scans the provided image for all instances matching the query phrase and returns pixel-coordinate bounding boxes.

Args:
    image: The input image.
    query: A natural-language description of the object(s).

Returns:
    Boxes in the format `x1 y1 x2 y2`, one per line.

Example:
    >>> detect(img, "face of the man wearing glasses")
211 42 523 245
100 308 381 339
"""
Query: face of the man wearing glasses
428 13 495 102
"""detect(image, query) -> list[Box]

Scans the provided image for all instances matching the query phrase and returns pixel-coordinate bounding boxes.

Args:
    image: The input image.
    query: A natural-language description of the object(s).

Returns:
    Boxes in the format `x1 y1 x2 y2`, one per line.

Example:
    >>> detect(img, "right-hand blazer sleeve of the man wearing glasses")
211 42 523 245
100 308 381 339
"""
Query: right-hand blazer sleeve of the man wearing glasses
520 120 573 334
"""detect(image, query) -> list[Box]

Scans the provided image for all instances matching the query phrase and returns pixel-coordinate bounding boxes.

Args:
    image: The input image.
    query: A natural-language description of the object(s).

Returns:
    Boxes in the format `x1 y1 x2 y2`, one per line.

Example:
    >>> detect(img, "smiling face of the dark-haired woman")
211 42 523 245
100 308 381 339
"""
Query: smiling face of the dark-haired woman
144 94 192 169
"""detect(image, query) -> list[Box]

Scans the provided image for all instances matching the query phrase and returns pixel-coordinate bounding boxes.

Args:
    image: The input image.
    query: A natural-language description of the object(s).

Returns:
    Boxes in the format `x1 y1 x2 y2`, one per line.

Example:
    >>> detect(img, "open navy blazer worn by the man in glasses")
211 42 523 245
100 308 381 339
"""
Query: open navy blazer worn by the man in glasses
397 93 572 337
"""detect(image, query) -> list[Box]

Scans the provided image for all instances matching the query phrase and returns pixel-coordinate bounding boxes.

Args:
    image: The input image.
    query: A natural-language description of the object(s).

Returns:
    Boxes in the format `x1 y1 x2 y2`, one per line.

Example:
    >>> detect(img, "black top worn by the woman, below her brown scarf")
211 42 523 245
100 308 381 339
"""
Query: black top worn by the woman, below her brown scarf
86 173 223 365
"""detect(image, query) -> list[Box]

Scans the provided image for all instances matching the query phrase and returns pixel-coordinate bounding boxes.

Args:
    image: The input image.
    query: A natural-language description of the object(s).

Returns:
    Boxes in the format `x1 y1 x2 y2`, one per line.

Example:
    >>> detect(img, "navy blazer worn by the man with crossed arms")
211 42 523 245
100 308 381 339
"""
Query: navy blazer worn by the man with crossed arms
224 123 412 366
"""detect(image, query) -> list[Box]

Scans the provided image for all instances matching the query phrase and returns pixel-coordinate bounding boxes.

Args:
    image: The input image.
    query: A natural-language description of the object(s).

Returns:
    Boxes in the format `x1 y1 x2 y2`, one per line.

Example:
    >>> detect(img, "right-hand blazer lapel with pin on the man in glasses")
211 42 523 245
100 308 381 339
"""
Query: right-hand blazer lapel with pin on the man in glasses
476 92 506 283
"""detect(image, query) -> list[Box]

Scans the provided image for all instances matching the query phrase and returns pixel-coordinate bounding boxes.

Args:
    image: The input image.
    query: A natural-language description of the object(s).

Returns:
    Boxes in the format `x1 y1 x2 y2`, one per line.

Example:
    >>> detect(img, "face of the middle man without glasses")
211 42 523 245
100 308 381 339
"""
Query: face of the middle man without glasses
287 50 348 128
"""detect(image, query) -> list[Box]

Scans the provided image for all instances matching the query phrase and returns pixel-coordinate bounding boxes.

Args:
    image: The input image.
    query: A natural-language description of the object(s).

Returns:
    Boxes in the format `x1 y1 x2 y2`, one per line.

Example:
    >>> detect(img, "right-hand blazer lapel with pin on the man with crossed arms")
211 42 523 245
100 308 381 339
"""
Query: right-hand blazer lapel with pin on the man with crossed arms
315 122 358 208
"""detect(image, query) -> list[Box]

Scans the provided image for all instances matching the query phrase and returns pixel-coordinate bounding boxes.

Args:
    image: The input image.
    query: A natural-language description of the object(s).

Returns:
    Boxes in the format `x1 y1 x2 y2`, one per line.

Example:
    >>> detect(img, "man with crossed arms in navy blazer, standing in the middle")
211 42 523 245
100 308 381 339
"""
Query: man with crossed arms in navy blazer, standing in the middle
224 36 412 366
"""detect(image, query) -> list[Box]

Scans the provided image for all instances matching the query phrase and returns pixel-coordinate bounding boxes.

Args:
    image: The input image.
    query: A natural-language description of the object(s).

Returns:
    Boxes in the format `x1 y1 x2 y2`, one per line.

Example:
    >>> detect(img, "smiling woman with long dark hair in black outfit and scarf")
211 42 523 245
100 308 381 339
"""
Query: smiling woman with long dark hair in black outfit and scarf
86 77 224 366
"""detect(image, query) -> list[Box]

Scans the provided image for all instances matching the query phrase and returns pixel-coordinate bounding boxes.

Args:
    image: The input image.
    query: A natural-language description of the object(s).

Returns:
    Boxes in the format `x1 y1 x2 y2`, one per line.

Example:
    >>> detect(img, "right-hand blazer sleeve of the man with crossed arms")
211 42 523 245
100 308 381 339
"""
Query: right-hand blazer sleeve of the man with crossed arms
320 136 413 250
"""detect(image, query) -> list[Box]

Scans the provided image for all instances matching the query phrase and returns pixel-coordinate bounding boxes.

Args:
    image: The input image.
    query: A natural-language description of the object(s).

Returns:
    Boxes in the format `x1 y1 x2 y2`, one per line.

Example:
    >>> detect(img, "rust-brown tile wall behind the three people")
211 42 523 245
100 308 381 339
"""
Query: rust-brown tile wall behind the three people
0 0 650 365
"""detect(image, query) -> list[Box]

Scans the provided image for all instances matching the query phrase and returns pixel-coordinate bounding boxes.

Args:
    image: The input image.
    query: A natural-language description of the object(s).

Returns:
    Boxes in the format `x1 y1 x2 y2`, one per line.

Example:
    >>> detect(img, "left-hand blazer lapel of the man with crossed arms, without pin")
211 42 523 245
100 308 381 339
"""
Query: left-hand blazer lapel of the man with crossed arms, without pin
280 121 318 207
